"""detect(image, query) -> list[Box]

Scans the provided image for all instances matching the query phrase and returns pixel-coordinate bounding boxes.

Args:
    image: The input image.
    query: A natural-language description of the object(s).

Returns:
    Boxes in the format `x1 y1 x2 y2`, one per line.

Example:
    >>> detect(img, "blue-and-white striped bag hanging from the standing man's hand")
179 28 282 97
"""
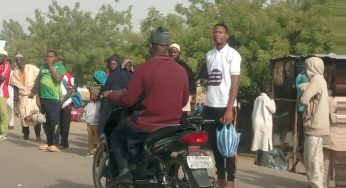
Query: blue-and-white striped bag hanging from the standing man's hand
216 124 240 158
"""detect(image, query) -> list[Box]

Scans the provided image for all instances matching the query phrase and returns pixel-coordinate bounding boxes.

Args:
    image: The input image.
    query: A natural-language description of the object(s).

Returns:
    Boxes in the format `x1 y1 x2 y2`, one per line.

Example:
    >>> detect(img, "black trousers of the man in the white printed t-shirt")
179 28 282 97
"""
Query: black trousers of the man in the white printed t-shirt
202 106 236 181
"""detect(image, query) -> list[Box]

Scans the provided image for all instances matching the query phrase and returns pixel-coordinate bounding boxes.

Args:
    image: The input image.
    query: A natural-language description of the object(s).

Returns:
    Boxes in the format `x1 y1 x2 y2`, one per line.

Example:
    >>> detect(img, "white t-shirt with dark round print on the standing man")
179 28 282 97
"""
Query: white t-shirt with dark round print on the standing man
205 44 241 108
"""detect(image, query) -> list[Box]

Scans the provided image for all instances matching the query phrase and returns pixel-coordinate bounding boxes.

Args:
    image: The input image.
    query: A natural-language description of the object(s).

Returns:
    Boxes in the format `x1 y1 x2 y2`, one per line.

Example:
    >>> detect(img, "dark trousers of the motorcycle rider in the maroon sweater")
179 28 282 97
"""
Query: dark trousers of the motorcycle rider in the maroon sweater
110 119 149 173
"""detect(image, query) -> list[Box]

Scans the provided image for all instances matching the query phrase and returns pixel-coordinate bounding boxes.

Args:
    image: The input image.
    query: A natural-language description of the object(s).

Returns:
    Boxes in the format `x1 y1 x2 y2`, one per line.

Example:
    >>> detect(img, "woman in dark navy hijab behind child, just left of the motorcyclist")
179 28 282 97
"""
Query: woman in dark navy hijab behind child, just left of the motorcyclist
98 55 128 135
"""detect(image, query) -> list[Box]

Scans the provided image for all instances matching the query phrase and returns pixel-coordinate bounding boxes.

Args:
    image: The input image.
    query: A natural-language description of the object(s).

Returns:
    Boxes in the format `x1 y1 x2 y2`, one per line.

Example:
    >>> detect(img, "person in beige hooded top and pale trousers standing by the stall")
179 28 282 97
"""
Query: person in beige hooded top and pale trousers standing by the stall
300 57 329 188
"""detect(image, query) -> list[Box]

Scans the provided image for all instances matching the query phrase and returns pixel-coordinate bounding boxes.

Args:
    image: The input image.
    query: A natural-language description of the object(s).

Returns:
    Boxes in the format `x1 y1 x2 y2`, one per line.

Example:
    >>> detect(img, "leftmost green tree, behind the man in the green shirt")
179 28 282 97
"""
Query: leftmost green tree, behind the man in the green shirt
1 1 136 83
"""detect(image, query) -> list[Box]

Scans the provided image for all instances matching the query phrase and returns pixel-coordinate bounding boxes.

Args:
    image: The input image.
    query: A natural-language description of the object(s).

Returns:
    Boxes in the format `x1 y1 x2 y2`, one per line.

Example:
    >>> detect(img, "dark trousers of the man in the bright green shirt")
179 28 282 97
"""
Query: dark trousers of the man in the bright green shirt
41 98 61 146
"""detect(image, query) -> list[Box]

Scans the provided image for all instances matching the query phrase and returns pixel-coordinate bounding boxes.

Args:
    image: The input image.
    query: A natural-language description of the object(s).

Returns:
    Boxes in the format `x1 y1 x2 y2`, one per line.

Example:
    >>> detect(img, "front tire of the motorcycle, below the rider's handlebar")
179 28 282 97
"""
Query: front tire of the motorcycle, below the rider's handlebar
92 143 112 188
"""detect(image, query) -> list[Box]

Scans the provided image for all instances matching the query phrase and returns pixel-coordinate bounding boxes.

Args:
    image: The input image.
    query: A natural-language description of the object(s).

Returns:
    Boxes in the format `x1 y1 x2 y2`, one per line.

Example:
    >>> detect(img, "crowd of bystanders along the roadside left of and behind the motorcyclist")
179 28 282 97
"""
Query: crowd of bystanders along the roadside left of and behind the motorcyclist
0 29 201 153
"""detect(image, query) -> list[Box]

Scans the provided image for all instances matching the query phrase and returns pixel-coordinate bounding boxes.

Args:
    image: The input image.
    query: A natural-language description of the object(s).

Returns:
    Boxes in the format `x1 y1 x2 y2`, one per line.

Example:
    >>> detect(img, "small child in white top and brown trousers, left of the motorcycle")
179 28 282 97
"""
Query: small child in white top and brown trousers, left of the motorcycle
81 87 101 157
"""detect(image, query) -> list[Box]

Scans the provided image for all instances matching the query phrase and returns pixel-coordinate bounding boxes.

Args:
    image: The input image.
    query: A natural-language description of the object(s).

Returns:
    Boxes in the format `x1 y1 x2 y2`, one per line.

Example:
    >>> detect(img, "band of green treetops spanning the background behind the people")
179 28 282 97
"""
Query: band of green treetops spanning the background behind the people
0 0 336 98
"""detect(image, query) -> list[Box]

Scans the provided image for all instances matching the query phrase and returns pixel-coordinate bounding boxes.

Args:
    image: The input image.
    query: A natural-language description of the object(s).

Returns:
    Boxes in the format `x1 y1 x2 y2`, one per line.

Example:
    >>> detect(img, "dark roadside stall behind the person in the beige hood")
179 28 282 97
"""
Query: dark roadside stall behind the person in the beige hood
270 54 346 187
